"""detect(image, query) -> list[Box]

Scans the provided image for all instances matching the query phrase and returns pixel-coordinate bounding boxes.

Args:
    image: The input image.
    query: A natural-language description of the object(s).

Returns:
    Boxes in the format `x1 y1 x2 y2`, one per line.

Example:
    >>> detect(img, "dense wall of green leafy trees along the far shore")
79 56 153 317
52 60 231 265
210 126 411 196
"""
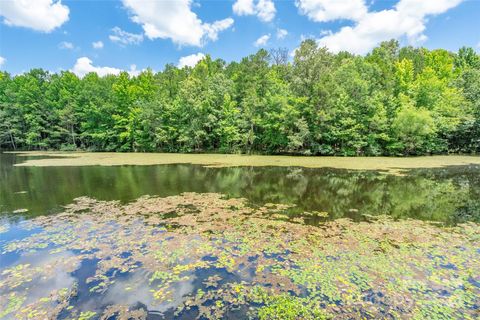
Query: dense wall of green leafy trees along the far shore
0 40 480 155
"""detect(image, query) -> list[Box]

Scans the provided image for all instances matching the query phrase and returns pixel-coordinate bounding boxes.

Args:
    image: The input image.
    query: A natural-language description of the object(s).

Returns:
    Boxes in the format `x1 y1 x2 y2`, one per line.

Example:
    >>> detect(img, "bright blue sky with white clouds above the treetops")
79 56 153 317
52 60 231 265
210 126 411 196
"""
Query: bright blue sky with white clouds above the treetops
0 0 480 75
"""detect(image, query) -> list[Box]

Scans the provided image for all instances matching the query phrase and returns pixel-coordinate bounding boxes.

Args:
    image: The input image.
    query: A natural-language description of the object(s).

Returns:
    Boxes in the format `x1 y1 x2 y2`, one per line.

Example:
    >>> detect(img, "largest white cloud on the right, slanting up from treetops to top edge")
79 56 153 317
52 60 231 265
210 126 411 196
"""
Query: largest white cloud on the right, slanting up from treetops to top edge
318 0 463 54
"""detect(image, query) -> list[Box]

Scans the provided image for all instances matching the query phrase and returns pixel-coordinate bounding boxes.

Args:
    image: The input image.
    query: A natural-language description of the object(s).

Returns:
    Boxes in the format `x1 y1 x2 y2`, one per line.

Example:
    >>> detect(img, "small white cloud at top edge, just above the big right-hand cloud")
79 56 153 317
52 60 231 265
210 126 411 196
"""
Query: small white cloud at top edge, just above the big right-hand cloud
295 0 368 22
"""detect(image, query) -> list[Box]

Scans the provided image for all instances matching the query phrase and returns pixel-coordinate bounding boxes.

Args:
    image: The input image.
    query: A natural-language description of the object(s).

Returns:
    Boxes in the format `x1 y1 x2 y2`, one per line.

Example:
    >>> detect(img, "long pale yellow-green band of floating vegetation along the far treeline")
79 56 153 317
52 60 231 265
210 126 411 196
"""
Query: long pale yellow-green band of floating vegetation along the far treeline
10 152 480 173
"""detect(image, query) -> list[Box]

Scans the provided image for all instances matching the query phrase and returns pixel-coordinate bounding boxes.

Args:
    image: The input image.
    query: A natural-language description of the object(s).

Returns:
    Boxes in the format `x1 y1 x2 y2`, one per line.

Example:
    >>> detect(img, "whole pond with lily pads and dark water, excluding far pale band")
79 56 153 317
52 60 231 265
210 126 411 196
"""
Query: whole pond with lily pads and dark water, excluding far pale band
0 154 480 319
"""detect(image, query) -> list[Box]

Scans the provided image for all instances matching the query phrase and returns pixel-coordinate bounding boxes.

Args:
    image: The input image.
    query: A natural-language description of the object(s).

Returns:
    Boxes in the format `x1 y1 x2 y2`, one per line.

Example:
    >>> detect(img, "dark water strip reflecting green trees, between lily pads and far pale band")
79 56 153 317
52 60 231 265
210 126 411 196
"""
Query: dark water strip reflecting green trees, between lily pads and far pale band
0 154 480 225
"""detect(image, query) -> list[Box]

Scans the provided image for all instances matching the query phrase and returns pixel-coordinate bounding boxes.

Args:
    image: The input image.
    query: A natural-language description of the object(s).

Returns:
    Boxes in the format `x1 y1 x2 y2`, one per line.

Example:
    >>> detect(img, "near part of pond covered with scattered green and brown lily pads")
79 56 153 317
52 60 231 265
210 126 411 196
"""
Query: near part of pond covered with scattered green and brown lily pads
0 193 480 319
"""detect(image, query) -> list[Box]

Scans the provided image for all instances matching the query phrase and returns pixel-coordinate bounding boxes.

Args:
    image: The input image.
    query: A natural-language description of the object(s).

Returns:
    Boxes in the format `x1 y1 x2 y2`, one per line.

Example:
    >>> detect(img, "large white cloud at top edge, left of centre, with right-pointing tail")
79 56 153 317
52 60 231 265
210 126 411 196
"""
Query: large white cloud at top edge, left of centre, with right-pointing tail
123 0 233 47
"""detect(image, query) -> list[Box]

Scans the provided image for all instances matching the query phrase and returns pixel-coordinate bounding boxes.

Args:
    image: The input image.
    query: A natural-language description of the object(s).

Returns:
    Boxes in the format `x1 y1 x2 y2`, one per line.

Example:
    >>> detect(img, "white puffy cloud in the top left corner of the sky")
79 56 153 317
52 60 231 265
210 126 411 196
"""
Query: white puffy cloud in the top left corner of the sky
0 0 70 32
